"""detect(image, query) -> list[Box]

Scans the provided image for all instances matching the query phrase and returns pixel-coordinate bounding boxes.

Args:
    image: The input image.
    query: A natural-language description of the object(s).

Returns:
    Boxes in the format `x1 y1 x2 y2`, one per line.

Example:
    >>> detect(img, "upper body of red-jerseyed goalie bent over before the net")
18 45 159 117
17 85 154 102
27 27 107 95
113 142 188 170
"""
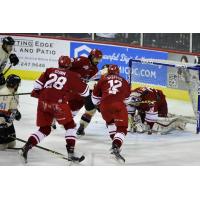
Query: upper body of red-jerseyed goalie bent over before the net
128 87 168 134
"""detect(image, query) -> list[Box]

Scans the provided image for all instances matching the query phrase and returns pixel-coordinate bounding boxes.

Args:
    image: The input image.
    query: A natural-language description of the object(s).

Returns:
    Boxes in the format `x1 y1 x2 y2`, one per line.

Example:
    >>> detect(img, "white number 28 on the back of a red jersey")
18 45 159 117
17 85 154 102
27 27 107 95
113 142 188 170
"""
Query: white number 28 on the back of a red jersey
44 73 67 90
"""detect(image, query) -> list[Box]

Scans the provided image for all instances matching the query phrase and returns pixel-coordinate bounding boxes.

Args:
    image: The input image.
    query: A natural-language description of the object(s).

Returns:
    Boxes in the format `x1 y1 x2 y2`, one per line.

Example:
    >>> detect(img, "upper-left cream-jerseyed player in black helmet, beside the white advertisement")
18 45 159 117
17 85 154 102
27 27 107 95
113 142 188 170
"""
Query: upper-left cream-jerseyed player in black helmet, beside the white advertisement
0 37 19 85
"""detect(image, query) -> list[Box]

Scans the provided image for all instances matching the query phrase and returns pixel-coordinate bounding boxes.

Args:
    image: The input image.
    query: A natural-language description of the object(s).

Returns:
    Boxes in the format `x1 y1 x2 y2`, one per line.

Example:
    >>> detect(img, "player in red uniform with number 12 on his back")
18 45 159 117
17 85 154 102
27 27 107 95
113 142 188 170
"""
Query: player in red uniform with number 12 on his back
92 65 130 161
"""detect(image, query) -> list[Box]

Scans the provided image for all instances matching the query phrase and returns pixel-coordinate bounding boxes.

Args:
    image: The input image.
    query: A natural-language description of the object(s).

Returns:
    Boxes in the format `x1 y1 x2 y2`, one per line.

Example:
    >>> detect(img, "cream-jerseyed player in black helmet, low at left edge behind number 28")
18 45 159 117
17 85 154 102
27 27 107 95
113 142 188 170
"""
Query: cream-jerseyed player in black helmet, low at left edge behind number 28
0 74 21 150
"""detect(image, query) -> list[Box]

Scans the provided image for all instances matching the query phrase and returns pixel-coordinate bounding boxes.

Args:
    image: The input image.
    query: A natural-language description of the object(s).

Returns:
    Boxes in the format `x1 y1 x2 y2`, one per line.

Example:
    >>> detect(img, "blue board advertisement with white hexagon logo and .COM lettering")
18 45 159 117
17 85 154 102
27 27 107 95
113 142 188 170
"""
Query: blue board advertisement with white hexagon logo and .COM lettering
70 42 168 86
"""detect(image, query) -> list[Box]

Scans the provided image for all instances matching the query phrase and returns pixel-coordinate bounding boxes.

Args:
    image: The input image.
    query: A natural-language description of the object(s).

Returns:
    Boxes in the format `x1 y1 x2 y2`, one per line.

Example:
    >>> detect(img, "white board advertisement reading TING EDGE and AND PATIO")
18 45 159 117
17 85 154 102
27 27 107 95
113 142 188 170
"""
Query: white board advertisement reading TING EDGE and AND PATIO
0 35 69 72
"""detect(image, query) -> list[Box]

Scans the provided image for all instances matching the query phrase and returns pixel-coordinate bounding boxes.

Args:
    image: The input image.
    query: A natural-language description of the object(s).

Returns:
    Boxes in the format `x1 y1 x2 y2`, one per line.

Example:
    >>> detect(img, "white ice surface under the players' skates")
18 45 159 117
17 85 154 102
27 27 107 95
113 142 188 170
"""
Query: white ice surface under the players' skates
0 81 200 166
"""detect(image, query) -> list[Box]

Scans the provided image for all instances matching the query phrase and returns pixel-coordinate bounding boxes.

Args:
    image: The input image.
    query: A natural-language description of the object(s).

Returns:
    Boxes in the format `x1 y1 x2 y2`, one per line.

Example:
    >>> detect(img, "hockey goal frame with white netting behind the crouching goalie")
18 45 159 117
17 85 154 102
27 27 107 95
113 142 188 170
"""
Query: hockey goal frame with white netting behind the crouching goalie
128 59 200 134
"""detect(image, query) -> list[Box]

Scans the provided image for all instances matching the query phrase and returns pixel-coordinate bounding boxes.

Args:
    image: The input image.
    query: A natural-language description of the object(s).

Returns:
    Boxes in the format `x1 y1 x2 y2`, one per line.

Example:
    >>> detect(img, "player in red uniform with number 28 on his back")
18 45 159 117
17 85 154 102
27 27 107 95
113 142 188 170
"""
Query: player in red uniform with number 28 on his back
20 56 89 161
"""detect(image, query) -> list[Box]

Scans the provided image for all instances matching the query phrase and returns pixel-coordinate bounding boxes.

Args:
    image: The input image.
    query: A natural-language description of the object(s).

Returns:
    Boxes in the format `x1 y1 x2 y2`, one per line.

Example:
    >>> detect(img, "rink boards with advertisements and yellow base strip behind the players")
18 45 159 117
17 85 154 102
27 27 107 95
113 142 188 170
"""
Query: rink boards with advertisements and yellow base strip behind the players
0 34 195 101
